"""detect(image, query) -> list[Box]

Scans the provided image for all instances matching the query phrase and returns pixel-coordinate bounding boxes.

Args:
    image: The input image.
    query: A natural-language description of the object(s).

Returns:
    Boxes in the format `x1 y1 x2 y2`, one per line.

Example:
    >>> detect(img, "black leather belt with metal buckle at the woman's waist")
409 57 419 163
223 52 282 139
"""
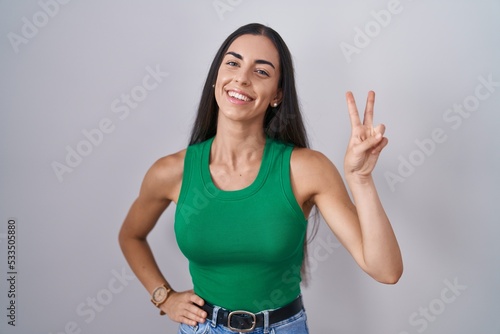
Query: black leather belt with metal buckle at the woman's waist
202 296 304 333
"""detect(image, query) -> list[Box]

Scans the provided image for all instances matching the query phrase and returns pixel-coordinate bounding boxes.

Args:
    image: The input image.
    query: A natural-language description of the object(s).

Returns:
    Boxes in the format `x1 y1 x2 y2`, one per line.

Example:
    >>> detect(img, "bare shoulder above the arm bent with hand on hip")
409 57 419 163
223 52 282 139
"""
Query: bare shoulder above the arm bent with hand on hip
141 149 186 202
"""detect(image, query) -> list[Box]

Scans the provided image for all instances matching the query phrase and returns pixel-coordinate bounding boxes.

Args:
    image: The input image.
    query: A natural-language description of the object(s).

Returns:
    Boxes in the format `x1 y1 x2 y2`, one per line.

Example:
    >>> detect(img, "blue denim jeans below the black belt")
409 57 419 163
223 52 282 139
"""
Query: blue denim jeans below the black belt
178 310 309 334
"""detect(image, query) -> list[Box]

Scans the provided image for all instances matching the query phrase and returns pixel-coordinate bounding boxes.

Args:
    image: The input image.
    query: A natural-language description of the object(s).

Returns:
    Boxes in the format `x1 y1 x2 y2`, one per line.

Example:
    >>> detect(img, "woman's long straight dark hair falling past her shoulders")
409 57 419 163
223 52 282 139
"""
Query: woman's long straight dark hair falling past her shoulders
189 23 309 147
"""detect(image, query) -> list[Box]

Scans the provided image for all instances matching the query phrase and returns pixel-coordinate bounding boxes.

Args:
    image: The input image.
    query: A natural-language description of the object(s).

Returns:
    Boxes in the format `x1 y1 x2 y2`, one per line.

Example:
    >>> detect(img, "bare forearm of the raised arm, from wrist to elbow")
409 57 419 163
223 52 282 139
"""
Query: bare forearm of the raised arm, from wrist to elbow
346 176 403 283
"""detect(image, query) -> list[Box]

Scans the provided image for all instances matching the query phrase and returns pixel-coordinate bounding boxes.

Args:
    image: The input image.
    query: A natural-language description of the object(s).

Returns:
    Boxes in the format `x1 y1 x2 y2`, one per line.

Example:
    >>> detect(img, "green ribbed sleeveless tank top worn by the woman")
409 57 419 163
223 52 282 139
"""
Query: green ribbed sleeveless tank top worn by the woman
175 138 307 312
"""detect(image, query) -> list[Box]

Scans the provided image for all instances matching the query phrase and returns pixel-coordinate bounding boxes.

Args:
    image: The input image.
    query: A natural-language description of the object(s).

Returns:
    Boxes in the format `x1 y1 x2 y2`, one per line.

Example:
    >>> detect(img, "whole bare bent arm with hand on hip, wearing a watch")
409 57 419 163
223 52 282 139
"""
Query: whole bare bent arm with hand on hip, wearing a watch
119 152 206 325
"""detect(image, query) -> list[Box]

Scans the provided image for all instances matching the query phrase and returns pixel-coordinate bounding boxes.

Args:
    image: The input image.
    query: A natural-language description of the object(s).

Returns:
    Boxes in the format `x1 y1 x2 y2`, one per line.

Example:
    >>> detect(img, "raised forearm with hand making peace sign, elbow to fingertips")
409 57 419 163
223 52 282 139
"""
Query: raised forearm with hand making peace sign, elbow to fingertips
344 92 403 283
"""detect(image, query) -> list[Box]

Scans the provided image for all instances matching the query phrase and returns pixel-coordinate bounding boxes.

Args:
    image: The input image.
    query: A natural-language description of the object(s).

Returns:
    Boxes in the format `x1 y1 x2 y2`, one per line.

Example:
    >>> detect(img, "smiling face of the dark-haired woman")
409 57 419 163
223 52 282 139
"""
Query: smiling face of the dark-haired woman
215 35 282 125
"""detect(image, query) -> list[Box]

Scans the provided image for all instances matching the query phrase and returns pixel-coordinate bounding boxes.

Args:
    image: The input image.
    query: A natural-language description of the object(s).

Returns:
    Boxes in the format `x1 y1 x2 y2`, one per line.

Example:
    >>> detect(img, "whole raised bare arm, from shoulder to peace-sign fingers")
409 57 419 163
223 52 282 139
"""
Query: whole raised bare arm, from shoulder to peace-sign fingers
292 92 403 284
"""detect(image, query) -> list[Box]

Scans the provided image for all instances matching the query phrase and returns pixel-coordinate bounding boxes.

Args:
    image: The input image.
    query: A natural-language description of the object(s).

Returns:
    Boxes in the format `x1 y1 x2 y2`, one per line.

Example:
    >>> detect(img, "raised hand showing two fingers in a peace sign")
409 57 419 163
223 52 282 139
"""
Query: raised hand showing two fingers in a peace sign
344 91 388 179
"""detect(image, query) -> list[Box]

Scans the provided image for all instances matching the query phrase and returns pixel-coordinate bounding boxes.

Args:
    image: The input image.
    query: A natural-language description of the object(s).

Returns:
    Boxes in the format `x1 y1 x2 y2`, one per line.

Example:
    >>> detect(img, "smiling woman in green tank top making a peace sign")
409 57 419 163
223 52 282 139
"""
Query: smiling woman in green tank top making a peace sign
119 24 403 334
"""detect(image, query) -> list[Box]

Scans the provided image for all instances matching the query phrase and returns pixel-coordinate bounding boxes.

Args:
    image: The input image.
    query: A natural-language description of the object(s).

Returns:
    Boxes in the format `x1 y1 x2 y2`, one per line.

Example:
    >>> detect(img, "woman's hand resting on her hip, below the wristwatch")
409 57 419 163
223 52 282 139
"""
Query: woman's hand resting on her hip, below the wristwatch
160 290 207 326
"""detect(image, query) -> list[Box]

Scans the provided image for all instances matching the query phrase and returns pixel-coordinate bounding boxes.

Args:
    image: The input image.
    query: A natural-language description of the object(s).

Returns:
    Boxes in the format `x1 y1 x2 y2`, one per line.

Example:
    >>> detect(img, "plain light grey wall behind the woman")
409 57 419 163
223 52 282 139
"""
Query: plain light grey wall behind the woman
0 0 500 334
